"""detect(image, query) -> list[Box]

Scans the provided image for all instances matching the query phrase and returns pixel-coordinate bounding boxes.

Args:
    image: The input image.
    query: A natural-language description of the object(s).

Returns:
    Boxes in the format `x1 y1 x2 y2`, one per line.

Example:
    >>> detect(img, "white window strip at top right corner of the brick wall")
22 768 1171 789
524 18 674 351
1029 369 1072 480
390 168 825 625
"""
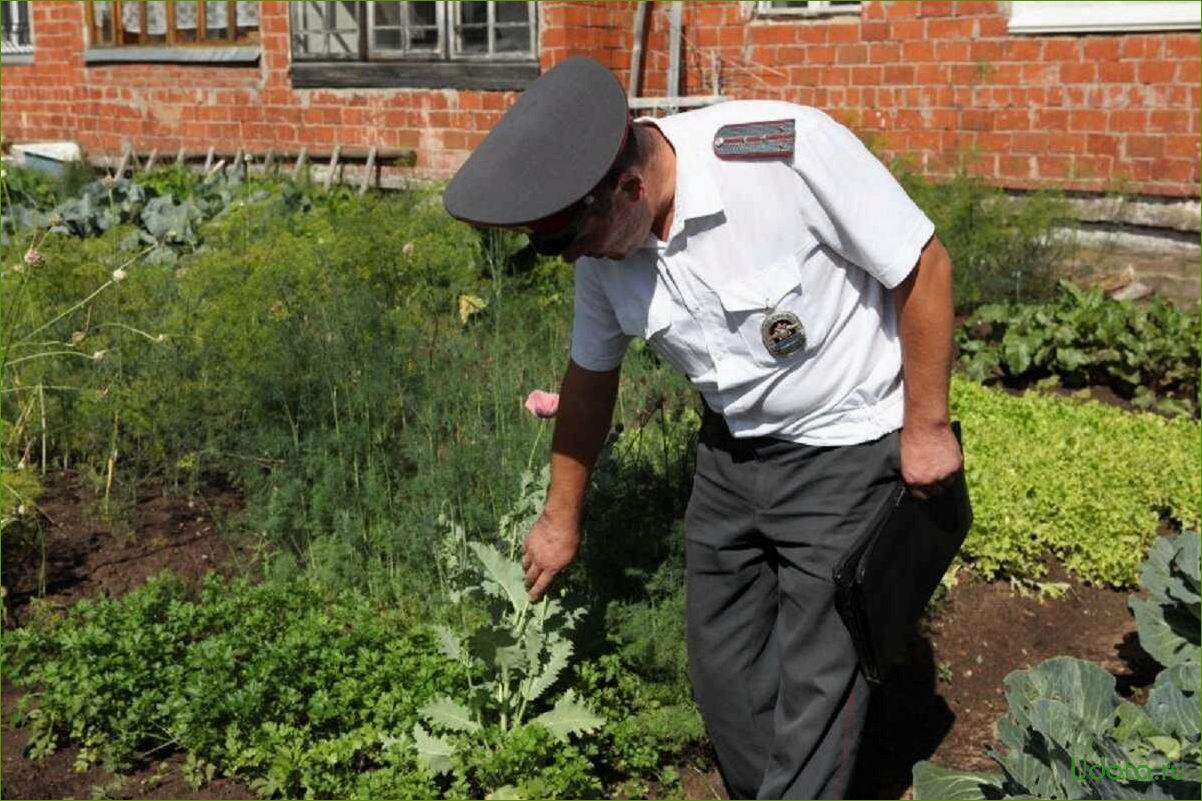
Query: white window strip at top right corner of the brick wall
1010 0 1202 34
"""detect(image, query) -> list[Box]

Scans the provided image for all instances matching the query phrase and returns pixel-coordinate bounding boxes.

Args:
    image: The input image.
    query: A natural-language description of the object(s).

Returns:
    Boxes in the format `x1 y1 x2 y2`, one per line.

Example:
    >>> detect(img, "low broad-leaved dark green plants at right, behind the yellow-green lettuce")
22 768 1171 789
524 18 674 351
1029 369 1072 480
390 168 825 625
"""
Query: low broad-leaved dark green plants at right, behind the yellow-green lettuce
956 281 1202 414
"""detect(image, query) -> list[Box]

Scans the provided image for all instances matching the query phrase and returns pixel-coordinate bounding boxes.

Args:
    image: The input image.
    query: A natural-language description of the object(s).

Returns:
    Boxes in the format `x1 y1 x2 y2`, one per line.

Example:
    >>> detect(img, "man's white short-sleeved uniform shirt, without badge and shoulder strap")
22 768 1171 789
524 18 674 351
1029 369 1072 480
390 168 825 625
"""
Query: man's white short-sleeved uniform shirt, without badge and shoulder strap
572 100 935 445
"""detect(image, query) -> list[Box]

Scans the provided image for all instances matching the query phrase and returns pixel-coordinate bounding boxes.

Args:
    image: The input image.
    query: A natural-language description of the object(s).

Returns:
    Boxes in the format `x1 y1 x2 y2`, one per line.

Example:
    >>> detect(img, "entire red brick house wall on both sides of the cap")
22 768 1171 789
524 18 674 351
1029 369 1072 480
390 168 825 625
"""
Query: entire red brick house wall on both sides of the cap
0 1 1202 197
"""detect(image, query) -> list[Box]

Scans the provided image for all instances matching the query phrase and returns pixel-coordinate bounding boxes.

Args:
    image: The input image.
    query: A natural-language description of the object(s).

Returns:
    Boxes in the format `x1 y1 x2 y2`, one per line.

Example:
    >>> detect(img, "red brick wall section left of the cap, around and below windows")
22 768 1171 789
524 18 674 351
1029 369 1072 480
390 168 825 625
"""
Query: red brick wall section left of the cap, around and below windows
0 1 516 176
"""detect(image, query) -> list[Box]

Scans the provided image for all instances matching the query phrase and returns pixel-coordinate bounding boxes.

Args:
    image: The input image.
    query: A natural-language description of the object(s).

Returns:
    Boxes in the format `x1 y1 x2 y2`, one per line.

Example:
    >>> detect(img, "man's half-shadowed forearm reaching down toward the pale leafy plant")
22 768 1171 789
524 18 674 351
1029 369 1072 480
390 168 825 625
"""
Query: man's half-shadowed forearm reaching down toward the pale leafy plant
543 363 619 529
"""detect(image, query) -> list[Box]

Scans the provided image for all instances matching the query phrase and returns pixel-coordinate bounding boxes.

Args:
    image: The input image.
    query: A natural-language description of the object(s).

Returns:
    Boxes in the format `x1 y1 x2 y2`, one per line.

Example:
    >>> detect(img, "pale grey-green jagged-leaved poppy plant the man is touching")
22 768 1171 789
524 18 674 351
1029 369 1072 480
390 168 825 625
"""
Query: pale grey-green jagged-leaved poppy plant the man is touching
412 473 605 797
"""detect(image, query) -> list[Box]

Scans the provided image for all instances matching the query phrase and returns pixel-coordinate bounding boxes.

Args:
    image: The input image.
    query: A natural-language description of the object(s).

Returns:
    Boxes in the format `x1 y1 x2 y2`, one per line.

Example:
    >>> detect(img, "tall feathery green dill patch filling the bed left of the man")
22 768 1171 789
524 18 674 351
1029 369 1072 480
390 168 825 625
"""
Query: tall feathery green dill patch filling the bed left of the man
0 171 688 608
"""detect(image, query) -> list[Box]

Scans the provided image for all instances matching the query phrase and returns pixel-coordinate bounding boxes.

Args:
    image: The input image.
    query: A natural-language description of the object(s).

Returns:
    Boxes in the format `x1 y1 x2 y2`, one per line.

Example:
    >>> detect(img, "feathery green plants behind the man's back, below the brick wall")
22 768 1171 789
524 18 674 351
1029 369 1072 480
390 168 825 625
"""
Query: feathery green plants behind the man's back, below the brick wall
894 165 1076 313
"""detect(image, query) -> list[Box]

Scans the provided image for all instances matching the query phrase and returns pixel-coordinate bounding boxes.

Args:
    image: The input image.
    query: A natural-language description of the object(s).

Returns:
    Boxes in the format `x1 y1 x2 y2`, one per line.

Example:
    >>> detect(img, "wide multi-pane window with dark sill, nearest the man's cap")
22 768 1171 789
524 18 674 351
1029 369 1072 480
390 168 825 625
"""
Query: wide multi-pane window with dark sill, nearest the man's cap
288 0 538 89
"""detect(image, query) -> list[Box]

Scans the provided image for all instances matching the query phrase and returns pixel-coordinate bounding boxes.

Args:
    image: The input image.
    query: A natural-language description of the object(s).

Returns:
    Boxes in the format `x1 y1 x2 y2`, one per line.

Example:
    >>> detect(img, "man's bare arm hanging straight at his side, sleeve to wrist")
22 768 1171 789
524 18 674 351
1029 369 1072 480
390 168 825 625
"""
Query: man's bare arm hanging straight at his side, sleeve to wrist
893 237 954 428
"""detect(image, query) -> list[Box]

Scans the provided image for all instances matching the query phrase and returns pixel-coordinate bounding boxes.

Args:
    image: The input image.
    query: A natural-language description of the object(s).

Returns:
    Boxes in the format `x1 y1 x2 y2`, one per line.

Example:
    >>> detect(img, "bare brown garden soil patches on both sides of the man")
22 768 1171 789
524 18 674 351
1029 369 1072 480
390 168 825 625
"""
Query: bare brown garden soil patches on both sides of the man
0 480 1158 799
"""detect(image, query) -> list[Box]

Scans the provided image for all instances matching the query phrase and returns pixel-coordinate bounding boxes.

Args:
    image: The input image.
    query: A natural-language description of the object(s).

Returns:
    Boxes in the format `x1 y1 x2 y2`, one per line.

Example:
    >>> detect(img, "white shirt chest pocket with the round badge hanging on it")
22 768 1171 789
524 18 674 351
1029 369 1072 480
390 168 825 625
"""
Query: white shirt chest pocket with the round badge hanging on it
713 251 825 368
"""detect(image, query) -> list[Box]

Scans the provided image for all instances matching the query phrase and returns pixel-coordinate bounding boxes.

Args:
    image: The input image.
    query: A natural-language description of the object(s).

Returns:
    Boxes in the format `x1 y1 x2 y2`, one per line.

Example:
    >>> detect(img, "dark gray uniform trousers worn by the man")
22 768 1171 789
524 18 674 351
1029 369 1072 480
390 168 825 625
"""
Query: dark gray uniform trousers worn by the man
685 413 900 799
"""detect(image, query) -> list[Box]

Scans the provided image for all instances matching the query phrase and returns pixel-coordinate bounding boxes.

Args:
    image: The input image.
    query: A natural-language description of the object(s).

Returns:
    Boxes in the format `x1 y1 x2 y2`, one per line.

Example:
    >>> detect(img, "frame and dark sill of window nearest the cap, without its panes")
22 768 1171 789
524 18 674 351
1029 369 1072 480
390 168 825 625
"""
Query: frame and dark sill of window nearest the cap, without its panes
288 0 541 90
